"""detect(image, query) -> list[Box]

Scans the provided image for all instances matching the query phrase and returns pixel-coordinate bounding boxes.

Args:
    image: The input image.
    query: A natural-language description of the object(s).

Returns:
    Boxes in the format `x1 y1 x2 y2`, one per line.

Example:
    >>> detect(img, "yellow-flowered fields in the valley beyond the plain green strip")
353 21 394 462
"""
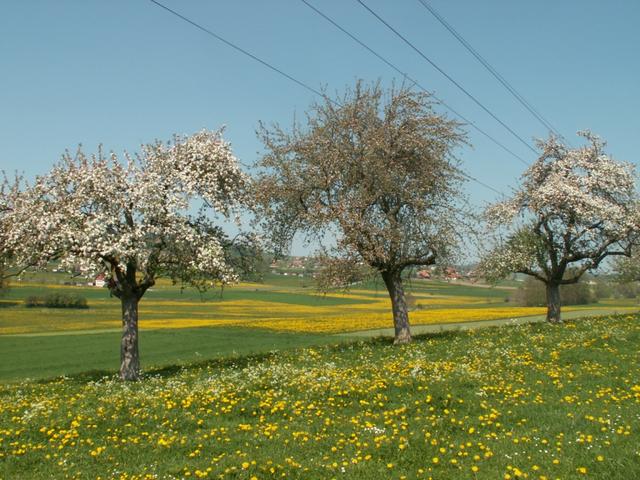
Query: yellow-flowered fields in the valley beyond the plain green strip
0 282 628 335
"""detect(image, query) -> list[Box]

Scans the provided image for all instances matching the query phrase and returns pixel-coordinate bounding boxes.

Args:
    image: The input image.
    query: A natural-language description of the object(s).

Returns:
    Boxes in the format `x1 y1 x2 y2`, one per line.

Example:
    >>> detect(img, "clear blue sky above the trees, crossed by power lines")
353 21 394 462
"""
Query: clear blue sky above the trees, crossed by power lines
0 0 640 244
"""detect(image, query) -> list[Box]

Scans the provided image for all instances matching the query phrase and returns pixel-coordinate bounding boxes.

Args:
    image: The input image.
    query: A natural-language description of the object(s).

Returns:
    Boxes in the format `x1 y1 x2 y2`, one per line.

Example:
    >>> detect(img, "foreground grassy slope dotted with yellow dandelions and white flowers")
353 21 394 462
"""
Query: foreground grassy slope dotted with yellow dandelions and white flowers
0 316 640 480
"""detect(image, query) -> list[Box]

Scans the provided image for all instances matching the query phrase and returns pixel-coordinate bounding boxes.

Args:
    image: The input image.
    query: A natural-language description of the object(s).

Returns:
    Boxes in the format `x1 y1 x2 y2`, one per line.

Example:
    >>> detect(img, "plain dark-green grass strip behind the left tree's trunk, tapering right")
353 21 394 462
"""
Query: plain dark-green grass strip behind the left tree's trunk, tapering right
0 327 340 382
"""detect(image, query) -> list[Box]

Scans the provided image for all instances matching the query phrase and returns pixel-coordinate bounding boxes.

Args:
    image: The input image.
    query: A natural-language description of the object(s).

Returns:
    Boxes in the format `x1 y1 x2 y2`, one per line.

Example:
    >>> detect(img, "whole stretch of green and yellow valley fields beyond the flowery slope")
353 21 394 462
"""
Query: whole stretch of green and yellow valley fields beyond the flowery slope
0 273 630 381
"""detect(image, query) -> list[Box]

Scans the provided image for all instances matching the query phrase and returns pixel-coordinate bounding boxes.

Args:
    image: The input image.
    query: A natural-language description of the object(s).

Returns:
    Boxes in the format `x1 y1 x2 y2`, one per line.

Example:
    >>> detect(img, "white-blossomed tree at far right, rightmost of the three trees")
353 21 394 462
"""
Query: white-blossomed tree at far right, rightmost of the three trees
480 132 640 323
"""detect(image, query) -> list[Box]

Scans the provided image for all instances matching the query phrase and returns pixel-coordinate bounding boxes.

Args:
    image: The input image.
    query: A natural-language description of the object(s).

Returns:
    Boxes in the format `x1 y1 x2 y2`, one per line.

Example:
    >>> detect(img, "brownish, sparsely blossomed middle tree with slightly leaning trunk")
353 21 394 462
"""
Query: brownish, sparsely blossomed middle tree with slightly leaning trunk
257 81 464 343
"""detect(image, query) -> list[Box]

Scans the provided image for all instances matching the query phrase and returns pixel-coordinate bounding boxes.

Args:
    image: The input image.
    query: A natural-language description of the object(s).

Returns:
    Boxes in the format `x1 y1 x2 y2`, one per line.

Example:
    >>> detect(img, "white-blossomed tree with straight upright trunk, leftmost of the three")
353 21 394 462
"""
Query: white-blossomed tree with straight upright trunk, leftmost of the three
6 131 248 380
